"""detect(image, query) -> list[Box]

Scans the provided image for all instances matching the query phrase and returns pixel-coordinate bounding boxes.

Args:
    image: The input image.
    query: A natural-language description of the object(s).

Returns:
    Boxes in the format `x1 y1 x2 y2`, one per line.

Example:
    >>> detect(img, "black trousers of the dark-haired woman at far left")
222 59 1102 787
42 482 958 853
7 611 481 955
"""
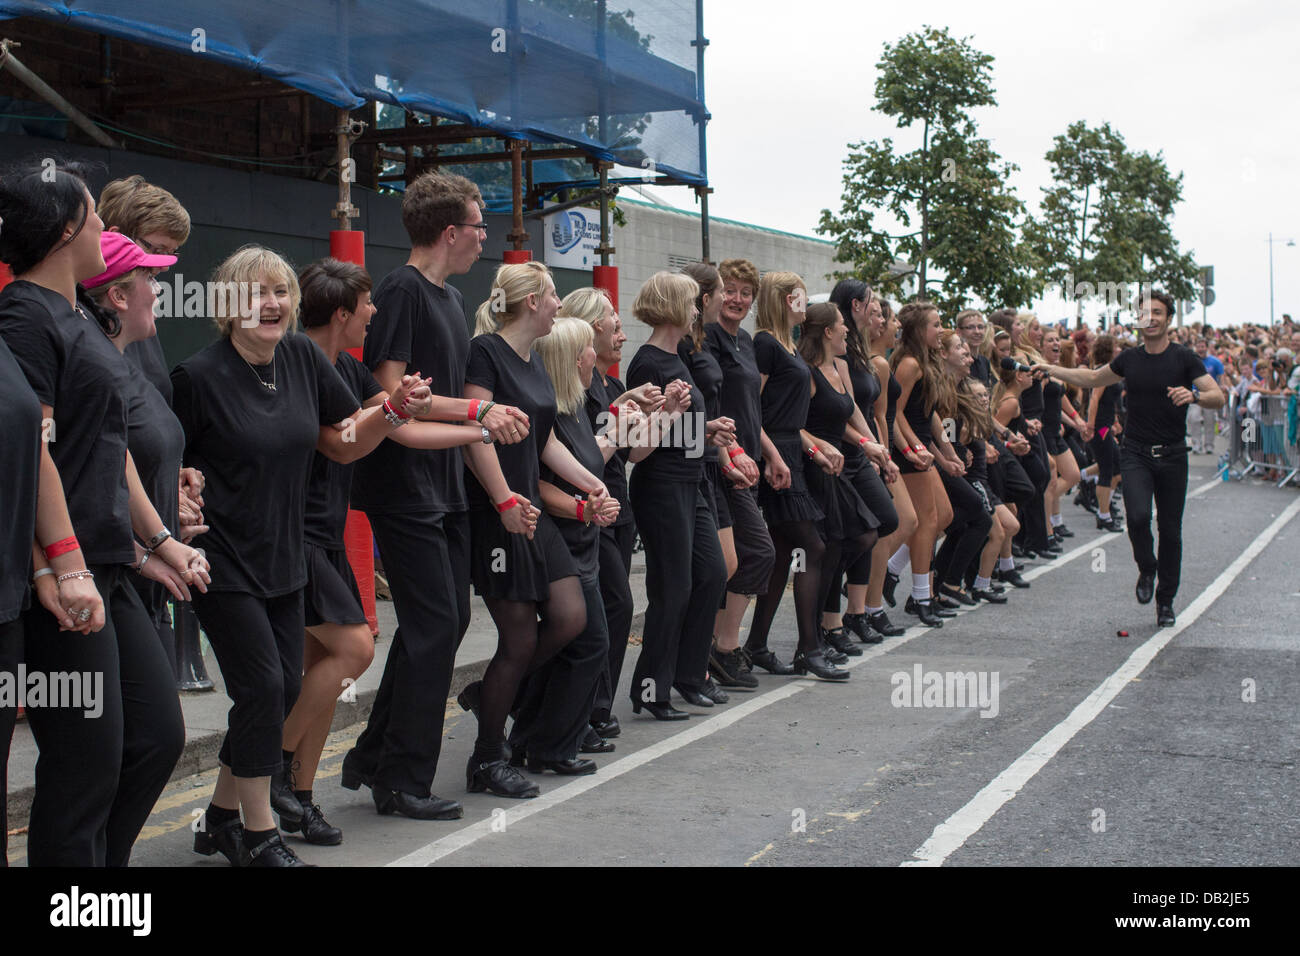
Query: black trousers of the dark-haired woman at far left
23 564 185 866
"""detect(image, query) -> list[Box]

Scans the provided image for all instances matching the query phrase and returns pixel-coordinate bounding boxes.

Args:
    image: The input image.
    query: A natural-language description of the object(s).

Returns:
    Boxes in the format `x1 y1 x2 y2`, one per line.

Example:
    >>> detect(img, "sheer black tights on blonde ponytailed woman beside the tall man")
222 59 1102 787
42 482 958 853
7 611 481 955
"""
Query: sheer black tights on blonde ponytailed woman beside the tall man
475 578 586 758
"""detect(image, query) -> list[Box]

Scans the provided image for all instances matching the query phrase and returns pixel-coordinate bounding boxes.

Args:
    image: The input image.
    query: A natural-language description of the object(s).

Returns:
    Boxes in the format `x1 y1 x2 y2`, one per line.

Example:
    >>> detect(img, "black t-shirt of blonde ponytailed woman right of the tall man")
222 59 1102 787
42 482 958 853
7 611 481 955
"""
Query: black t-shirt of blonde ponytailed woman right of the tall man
465 333 555 509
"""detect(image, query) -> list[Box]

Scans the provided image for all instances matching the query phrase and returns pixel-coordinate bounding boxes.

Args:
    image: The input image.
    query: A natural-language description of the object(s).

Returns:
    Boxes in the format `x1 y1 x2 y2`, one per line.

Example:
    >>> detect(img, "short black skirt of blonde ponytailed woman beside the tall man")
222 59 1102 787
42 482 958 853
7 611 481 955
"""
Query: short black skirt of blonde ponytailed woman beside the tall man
469 509 577 601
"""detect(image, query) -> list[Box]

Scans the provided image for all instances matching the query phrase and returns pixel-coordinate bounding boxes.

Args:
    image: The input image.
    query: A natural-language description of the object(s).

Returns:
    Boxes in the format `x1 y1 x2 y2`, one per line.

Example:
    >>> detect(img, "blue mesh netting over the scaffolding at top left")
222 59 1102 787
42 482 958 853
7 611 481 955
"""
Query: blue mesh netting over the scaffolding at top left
0 0 707 185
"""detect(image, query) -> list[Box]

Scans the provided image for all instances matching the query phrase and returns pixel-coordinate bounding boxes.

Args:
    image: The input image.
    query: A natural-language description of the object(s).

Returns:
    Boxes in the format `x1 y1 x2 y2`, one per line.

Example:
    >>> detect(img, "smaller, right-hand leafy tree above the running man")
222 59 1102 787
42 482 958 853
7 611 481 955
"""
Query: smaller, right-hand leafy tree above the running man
1024 121 1197 323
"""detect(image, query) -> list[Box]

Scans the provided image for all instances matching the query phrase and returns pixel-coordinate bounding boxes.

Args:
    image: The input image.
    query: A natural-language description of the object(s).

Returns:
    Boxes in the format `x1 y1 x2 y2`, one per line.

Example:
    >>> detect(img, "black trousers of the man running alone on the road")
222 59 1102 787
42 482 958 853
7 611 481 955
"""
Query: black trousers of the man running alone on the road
1119 446 1187 605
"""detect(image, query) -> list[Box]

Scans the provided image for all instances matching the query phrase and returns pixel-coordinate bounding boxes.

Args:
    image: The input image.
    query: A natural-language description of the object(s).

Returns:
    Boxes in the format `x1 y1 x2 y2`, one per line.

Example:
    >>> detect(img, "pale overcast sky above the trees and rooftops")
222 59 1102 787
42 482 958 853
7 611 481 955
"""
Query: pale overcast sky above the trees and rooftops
644 0 1300 325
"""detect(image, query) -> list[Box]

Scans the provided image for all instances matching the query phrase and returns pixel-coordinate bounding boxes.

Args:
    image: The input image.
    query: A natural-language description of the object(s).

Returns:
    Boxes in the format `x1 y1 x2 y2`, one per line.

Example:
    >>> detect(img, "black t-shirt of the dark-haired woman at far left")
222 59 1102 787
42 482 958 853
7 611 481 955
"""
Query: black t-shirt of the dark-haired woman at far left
0 280 135 564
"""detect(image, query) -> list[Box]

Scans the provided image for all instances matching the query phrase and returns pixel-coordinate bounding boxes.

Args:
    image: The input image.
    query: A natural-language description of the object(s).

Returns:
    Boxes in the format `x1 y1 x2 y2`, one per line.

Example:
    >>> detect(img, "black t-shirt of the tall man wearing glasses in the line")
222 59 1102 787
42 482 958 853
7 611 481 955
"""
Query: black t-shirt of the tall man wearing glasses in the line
352 265 469 515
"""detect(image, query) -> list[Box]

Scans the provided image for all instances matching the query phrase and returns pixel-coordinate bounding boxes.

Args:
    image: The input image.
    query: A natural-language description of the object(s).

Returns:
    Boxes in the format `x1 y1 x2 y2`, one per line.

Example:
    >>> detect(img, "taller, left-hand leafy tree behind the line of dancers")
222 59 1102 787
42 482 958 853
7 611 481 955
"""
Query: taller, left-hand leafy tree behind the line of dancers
818 26 1032 308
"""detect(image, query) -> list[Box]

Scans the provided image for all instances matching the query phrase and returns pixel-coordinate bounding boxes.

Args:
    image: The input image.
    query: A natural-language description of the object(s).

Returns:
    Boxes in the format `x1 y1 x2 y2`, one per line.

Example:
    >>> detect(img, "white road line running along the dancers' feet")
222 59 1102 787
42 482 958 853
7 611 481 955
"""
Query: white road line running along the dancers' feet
386 486 1227 866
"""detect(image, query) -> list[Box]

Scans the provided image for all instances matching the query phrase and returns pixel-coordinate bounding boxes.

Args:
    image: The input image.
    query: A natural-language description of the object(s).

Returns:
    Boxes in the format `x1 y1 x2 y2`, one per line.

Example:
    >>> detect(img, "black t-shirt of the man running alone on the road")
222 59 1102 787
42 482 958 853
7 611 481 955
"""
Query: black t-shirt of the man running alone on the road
1110 342 1205 445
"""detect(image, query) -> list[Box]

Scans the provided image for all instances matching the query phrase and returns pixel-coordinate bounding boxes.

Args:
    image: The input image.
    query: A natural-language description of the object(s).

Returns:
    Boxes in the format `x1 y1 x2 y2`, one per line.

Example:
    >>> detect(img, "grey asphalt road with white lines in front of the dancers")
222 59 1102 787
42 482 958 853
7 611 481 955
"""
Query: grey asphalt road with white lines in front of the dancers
10 458 1300 868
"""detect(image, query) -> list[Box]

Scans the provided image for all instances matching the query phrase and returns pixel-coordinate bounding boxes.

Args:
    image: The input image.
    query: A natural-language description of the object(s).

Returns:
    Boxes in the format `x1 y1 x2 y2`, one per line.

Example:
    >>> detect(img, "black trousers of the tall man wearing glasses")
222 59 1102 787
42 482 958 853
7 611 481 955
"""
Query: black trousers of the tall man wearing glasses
352 512 469 797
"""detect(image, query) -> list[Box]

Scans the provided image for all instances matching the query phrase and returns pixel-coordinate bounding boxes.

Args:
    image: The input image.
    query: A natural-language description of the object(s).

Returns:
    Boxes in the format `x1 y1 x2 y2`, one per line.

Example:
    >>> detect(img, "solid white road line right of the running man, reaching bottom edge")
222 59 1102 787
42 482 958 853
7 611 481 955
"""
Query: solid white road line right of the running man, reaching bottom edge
900 499 1300 866
